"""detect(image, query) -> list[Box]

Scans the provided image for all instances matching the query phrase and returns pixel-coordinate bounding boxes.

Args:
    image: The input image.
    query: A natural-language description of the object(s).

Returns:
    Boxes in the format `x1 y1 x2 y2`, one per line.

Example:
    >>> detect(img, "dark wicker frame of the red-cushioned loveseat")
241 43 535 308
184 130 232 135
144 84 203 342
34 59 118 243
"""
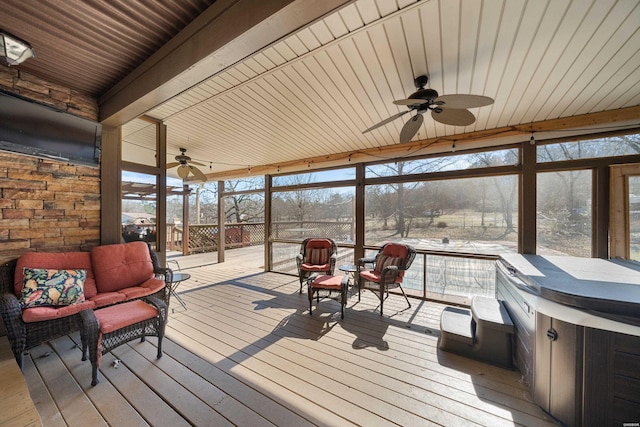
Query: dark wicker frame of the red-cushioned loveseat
0 249 170 368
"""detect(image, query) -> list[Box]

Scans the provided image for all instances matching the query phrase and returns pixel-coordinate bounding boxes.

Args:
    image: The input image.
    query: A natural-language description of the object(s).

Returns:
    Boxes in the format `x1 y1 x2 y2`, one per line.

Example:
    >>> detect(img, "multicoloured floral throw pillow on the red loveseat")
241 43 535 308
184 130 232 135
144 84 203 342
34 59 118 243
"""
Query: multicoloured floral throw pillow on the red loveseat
20 267 87 308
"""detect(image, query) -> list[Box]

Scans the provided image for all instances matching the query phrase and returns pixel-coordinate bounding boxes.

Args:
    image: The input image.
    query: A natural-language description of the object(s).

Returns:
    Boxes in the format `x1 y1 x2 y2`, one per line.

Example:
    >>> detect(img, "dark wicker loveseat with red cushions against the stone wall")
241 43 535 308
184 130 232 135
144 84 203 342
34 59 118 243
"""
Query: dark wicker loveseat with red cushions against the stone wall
0 242 170 368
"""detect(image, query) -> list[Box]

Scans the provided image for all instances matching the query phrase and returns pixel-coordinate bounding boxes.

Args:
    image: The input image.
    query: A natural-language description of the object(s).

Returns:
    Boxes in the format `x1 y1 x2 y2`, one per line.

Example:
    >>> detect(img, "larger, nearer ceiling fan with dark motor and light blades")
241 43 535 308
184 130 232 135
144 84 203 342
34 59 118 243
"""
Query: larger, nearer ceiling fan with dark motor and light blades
362 76 493 143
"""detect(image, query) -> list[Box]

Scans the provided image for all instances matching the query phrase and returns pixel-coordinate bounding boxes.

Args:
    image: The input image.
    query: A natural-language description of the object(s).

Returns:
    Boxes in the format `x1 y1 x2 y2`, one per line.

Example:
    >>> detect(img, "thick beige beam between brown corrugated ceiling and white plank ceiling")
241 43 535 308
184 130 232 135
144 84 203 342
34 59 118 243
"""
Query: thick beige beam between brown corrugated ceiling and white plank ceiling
99 0 352 126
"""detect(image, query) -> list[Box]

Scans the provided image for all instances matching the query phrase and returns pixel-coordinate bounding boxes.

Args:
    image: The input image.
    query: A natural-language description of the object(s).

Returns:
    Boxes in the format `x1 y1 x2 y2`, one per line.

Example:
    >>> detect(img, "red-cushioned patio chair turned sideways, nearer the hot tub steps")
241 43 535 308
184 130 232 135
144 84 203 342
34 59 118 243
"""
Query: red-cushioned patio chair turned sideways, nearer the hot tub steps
356 243 416 316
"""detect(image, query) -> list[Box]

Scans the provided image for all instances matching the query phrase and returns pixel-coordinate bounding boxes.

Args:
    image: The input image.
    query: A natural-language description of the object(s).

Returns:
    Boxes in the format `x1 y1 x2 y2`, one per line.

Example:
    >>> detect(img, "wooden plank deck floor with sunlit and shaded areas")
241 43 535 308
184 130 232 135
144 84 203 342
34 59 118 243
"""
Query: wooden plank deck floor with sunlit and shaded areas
24 252 555 427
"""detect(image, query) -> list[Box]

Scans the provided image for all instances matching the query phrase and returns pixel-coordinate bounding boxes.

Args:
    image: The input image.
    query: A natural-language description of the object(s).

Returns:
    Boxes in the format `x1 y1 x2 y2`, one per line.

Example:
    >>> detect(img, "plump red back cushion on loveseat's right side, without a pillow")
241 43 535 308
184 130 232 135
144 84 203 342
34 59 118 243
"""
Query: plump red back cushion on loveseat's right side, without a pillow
91 242 154 293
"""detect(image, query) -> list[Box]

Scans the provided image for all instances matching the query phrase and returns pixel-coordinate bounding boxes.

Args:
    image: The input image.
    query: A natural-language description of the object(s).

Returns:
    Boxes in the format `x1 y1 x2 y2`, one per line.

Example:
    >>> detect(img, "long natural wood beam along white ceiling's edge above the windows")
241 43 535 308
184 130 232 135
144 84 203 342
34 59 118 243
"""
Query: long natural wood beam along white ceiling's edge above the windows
196 106 640 180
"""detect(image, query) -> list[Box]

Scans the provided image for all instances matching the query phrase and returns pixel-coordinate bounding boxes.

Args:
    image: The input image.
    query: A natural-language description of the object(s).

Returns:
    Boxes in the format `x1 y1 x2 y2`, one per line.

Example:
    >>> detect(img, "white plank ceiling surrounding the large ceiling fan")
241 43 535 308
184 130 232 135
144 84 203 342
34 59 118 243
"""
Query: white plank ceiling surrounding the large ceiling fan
125 0 640 181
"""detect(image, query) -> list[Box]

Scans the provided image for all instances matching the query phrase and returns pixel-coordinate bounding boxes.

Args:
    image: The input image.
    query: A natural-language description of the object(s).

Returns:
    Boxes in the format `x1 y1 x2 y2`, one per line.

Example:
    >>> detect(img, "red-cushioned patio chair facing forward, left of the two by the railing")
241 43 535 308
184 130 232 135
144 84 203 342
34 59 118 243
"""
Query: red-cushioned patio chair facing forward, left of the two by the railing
296 237 338 293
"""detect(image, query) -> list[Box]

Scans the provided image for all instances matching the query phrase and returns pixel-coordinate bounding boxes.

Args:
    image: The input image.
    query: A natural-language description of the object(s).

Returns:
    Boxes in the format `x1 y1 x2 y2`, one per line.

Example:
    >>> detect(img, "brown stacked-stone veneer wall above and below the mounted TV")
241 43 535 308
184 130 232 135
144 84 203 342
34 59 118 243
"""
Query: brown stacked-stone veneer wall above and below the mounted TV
0 65 100 262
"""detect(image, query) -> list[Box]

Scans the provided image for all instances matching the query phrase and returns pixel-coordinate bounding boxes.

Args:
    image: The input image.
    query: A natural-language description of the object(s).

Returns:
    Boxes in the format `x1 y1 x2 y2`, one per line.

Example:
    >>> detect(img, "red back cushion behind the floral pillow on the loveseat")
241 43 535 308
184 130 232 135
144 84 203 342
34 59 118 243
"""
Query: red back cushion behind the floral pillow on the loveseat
13 252 97 299
